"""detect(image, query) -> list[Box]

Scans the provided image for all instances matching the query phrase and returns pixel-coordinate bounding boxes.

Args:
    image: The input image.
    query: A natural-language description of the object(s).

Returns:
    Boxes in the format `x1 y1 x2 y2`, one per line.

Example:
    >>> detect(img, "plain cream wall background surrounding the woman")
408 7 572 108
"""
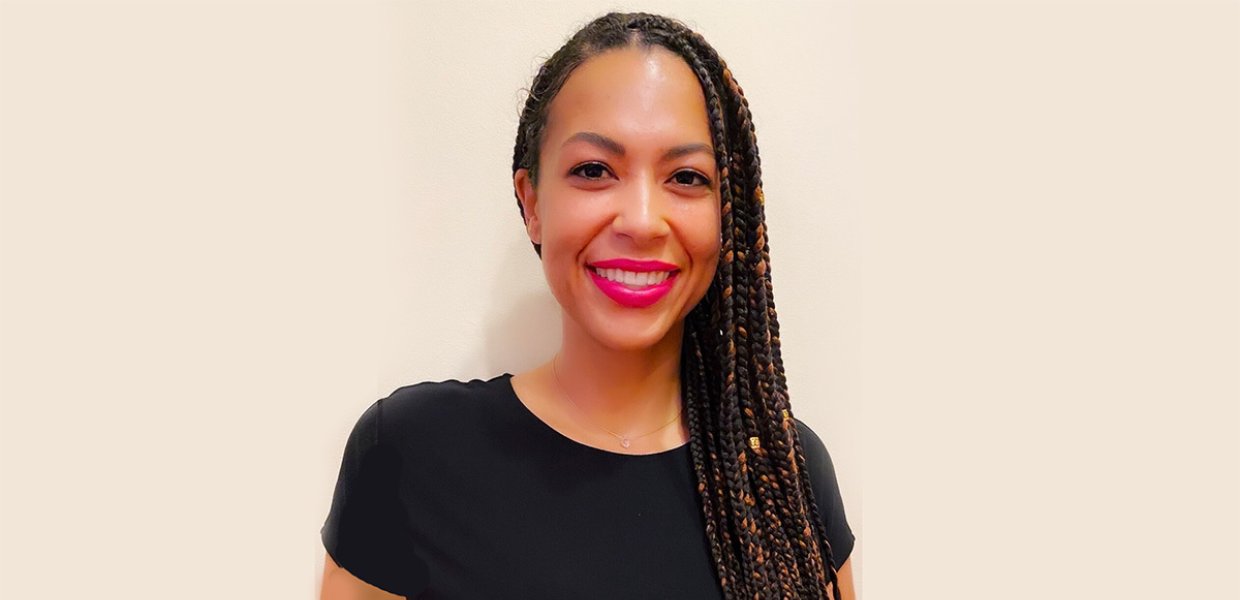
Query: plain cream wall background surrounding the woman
0 0 1240 600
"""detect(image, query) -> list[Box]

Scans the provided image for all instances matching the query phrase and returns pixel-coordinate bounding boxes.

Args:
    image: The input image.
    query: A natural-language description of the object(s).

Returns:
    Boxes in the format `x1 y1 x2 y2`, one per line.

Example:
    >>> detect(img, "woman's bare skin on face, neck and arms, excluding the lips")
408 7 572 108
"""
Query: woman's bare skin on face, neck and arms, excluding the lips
321 46 856 600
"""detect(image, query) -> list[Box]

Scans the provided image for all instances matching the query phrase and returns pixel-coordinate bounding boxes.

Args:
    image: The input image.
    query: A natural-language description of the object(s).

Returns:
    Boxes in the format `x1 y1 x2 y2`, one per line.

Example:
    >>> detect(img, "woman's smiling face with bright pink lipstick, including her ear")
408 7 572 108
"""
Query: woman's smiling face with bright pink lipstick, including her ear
515 46 719 350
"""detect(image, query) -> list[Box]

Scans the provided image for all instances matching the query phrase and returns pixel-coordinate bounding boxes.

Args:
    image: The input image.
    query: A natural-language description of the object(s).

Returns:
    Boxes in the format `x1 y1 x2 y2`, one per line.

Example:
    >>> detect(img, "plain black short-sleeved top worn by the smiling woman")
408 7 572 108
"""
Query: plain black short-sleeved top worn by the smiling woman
321 373 854 600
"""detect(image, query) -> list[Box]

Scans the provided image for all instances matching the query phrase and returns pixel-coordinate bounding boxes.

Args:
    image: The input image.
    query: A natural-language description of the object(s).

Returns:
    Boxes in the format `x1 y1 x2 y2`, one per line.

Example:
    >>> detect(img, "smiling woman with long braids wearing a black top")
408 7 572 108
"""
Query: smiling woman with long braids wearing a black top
322 14 853 599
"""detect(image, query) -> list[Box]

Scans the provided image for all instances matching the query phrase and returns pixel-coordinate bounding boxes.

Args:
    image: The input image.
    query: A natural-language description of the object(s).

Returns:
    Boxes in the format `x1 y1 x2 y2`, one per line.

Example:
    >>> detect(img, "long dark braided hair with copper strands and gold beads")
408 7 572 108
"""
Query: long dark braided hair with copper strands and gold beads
512 12 839 600
